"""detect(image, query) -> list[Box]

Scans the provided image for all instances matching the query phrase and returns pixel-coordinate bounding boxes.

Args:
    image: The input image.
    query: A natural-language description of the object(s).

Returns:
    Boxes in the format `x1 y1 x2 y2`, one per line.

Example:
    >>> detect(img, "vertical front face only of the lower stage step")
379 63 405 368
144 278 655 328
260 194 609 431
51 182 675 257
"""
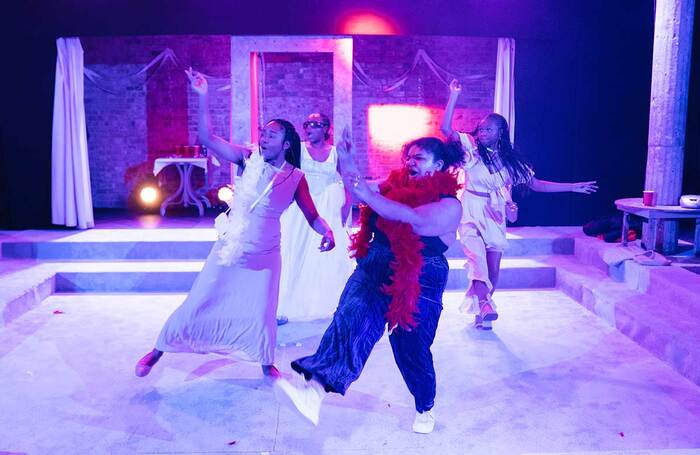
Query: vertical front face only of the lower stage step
56 267 556 293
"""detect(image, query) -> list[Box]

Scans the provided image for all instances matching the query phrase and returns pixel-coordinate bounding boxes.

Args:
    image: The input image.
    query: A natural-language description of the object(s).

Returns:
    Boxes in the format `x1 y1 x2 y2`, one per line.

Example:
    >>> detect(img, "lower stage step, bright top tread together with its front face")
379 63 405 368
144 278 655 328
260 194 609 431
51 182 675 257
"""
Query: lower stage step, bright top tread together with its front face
49 258 556 293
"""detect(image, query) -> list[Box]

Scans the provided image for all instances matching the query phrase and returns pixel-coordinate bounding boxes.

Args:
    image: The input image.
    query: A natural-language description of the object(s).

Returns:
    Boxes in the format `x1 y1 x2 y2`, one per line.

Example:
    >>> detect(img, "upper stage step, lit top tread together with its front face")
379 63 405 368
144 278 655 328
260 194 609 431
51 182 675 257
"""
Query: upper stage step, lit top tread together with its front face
0 227 578 261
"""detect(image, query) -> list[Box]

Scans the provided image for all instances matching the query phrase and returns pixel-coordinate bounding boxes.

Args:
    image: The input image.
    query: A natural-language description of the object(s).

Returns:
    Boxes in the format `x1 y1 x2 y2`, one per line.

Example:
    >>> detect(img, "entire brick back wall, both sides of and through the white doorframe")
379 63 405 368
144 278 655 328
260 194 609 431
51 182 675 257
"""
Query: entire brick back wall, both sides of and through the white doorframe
81 36 497 207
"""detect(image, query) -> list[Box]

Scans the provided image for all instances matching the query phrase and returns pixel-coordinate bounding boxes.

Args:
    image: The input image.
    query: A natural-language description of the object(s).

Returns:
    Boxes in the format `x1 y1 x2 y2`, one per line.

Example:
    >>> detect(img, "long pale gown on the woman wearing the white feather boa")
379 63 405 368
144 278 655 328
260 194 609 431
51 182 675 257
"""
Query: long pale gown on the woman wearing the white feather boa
156 163 310 365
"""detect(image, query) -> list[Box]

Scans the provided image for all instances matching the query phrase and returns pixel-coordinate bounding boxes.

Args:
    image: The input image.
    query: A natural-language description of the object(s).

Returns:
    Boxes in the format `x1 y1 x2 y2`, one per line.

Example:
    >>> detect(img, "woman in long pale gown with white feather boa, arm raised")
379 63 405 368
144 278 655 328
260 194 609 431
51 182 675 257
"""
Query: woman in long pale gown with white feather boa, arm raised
136 69 335 377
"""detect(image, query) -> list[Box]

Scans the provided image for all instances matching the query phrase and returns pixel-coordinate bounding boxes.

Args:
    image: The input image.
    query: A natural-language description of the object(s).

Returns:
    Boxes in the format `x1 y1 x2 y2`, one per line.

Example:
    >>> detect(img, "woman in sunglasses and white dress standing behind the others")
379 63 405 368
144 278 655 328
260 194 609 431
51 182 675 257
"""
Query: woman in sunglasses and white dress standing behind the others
277 114 355 322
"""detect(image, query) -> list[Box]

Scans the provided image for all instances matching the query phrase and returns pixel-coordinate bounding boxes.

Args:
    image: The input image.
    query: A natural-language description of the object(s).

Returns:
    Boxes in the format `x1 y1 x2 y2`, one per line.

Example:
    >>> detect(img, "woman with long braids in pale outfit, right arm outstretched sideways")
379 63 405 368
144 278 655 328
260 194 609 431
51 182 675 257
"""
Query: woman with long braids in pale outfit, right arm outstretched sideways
440 80 598 330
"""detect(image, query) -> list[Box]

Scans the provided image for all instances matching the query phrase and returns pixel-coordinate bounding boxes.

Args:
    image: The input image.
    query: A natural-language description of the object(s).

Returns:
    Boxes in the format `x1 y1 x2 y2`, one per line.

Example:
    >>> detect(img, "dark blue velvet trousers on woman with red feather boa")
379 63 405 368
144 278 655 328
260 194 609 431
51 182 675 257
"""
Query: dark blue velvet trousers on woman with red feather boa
292 243 449 412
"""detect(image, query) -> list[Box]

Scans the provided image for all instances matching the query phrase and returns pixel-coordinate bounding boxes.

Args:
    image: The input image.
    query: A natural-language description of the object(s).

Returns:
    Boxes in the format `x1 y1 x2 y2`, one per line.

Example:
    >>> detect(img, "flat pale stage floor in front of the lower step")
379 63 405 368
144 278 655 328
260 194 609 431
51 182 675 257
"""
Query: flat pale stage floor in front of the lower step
0 290 700 455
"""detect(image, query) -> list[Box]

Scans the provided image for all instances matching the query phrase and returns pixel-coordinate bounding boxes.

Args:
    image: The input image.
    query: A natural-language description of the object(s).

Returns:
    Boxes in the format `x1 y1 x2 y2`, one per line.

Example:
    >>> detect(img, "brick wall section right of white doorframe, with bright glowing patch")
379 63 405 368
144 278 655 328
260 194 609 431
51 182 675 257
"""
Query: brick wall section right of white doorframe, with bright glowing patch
352 36 497 178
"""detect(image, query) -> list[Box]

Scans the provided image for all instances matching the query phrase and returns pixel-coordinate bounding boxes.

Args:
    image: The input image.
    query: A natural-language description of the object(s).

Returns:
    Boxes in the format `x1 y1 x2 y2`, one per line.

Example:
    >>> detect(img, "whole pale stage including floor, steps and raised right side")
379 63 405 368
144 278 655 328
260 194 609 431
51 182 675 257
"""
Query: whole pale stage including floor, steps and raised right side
0 217 700 455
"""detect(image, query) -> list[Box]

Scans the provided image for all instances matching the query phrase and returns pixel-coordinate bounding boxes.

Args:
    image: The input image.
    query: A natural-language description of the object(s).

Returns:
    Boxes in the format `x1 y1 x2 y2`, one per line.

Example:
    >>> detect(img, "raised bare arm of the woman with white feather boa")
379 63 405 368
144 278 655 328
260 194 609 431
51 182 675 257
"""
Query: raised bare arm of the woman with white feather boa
185 68 250 165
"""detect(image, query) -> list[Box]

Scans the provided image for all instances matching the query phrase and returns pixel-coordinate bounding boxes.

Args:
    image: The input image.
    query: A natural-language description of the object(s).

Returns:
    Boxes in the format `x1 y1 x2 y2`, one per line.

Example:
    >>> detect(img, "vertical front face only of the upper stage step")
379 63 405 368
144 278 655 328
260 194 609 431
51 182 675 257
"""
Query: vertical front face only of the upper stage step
2 238 574 261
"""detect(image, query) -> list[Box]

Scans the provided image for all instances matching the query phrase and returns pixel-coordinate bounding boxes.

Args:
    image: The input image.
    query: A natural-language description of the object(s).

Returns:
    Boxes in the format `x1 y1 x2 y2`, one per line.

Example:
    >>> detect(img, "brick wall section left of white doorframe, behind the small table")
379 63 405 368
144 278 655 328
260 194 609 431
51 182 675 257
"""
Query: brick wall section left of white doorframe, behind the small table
81 36 231 207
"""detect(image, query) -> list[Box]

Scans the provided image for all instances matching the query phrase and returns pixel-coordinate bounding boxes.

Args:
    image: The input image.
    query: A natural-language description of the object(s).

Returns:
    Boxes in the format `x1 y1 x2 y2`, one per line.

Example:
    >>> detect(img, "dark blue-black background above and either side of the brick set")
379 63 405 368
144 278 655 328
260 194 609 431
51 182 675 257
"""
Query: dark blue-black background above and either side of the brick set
0 0 700 229
